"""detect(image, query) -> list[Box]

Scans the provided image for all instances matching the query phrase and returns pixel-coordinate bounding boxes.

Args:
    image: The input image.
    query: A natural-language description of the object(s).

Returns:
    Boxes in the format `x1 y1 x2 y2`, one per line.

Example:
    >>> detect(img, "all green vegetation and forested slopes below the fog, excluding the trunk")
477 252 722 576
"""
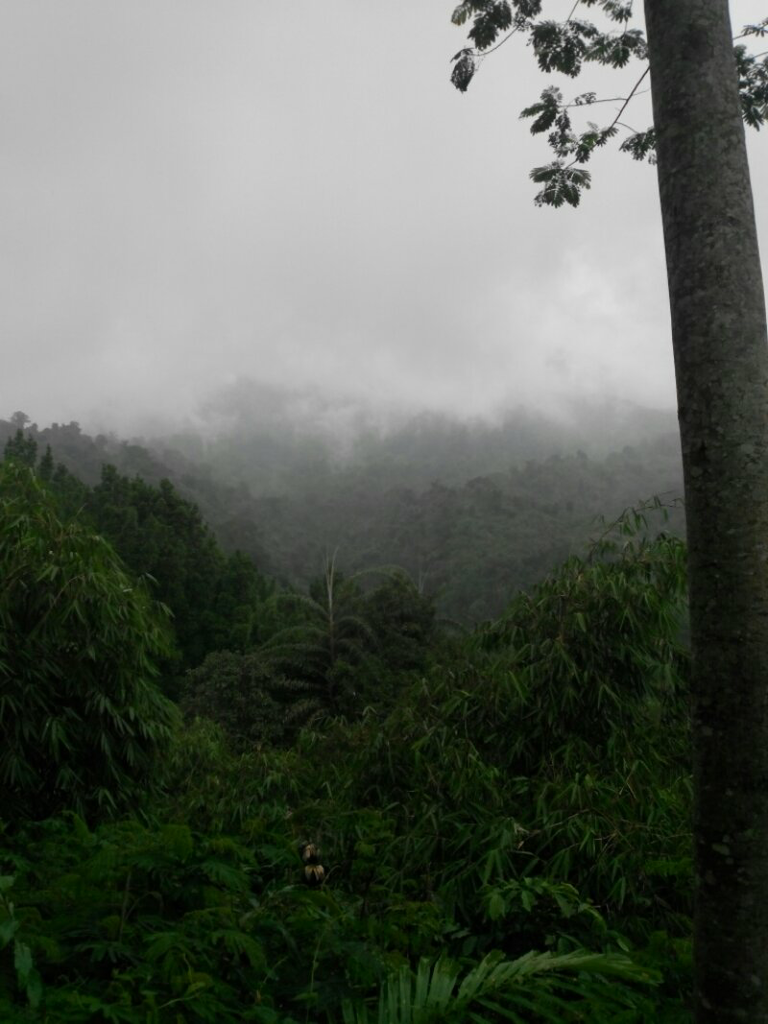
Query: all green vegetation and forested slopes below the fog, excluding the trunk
0 409 691 1024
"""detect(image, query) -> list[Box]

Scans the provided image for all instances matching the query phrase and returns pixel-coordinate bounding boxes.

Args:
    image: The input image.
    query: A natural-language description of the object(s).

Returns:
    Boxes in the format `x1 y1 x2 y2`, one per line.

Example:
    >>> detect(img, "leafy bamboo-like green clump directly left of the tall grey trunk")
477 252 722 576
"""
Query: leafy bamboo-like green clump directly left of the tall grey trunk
480 506 687 758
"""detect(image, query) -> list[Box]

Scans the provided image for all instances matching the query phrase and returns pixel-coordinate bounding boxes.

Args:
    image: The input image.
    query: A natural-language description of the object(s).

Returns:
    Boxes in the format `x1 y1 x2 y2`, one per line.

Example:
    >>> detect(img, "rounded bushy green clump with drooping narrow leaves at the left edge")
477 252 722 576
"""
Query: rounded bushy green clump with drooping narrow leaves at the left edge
0 461 175 817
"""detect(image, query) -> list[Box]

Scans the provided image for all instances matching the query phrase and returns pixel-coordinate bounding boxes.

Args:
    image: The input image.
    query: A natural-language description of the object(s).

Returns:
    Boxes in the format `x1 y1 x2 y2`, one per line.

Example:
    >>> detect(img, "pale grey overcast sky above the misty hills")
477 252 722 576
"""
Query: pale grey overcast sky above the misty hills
0 0 768 429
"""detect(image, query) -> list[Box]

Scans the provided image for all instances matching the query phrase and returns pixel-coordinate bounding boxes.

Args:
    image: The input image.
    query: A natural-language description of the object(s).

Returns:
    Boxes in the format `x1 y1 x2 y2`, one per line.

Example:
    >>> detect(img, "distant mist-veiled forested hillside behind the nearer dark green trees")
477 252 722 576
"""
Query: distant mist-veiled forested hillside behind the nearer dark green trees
0 401 683 625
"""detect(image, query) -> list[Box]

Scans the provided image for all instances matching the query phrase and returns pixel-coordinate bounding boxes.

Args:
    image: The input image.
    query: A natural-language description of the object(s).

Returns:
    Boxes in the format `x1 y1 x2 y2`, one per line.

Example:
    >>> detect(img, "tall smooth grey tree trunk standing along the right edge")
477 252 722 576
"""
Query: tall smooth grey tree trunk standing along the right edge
645 0 768 1024
